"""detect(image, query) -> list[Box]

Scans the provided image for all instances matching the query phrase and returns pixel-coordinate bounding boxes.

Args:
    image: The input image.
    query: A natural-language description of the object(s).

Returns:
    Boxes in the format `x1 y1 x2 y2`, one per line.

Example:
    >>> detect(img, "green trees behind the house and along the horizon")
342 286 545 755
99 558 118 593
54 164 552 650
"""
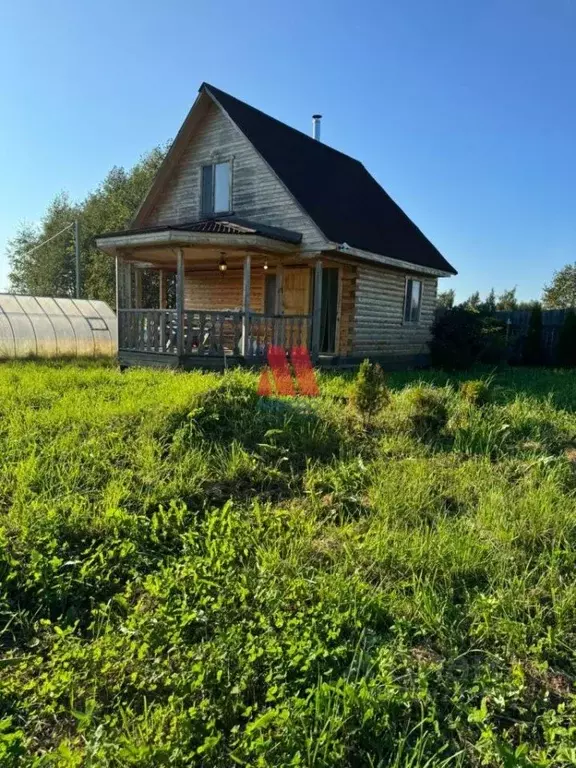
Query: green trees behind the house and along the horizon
7 145 576 313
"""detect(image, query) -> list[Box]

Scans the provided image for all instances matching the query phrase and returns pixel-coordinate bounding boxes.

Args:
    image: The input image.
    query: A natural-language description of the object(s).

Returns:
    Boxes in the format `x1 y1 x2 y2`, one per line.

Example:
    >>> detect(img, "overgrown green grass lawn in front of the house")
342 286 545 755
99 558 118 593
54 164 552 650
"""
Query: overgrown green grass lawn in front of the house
0 362 576 768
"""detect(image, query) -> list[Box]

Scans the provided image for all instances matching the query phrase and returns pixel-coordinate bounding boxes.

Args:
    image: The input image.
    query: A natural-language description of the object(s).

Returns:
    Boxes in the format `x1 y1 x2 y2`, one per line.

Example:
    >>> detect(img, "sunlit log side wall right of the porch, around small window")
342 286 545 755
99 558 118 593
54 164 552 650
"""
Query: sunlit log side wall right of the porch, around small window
352 266 438 356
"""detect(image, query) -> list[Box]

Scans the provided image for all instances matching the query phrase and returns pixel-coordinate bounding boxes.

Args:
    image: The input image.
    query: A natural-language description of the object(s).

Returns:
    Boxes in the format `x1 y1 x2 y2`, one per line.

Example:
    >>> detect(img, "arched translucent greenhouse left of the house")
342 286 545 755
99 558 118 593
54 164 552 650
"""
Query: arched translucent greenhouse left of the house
0 293 117 359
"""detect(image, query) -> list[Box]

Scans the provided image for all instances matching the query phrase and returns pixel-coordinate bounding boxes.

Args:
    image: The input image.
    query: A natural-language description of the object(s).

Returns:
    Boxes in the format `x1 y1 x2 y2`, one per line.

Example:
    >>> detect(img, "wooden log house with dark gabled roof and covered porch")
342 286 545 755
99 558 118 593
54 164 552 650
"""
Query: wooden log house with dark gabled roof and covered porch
97 83 456 367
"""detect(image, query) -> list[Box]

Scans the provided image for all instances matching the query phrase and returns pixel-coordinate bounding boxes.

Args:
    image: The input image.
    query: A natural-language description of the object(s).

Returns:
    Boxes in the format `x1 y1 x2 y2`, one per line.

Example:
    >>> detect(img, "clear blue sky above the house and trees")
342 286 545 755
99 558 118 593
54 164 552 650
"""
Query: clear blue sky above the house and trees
0 0 576 298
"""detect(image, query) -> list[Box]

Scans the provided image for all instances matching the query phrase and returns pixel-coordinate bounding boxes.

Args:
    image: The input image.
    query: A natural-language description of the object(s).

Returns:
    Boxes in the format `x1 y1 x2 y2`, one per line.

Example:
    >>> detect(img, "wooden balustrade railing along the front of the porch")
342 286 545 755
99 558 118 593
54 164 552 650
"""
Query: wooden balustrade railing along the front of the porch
118 309 312 358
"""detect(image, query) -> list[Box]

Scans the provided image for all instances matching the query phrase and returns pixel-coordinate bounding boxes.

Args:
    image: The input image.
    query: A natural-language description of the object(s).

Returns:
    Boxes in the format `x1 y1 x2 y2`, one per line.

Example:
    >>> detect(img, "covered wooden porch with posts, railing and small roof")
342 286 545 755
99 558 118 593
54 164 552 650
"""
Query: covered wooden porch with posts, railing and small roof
99 220 336 368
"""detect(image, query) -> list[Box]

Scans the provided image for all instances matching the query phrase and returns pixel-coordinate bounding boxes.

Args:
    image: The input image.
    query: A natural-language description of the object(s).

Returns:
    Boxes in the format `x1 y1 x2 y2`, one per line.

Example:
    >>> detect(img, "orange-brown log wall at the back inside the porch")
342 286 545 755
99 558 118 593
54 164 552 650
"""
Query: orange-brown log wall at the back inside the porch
184 268 265 312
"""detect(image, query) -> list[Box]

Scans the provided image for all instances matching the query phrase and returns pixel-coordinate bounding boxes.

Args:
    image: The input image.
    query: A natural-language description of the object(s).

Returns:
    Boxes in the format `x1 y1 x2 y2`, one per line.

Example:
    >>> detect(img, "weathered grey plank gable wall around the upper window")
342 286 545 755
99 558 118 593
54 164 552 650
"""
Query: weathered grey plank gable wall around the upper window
146 103 326 248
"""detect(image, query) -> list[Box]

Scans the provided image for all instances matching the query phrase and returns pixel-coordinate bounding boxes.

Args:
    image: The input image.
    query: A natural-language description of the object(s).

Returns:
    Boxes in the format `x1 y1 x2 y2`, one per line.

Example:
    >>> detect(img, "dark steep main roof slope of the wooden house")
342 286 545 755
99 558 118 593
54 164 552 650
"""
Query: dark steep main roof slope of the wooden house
205 83 456 274
